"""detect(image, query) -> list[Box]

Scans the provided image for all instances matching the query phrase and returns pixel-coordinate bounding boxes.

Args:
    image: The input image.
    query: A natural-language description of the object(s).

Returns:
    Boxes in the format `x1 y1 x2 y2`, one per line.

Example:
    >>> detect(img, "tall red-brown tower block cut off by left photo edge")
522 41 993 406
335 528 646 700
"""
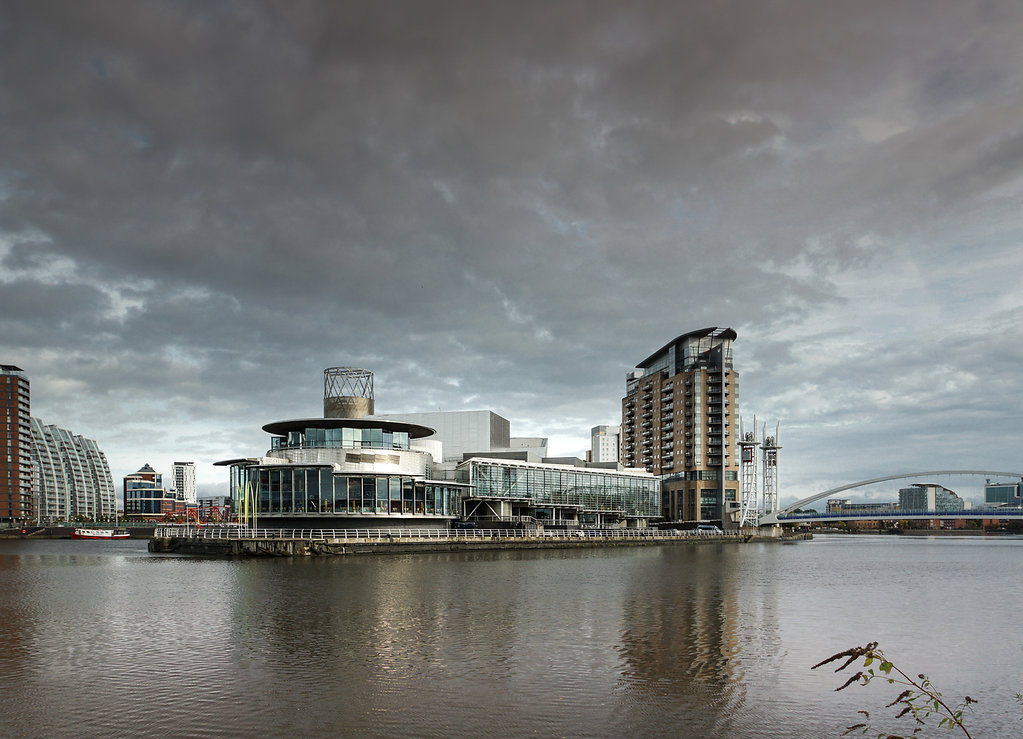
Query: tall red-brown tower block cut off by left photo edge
0 364 36 523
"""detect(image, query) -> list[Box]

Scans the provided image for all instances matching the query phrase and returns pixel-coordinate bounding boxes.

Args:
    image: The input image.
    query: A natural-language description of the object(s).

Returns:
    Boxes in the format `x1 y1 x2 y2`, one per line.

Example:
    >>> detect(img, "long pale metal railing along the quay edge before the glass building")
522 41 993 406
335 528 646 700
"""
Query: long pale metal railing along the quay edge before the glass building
154 524 739 541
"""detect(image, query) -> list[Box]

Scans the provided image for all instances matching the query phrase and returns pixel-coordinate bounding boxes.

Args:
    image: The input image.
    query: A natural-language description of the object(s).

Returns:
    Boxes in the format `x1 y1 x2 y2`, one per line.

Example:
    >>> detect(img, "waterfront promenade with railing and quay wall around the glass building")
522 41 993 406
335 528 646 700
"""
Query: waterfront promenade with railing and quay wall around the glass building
149 525 753 557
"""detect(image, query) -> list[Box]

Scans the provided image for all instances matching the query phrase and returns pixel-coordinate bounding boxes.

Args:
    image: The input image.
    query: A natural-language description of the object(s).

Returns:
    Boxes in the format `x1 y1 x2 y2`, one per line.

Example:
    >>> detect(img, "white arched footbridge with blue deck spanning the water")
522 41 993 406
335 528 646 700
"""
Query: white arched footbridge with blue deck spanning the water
759 470 1023 526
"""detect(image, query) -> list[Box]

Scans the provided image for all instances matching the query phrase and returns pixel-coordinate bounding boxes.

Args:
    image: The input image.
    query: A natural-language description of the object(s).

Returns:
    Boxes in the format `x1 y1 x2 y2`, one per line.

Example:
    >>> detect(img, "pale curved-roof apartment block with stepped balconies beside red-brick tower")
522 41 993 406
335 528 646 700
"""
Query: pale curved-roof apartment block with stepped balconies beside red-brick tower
32 418 117 522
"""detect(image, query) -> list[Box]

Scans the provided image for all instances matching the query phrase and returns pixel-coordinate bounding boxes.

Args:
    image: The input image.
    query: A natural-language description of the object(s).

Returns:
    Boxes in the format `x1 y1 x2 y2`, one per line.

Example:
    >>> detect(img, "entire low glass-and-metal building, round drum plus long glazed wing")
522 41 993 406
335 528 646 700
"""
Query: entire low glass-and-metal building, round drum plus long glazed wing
216 367 660 528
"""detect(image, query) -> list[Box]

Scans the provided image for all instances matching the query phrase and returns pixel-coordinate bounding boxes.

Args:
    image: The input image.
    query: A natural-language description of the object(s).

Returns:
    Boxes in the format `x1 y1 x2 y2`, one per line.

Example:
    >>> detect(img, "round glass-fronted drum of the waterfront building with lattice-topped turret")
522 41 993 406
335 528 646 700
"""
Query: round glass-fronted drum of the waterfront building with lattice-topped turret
215 367 468 528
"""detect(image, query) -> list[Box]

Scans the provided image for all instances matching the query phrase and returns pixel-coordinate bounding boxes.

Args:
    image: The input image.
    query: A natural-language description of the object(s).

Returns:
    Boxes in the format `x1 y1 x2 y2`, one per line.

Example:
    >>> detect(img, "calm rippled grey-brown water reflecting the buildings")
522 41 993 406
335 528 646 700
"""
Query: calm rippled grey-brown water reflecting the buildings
0 536 1023 737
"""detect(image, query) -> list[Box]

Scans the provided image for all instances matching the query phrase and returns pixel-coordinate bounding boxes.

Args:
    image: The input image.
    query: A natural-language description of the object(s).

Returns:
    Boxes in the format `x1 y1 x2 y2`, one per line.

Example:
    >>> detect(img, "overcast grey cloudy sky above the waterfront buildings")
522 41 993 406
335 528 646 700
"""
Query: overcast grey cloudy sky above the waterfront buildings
0 0 1023 503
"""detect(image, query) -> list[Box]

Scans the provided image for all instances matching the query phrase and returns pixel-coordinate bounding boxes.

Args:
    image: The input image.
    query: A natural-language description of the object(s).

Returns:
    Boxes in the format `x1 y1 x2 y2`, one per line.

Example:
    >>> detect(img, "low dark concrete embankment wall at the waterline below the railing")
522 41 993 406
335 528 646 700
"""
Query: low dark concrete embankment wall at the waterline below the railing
149 534 808 557
